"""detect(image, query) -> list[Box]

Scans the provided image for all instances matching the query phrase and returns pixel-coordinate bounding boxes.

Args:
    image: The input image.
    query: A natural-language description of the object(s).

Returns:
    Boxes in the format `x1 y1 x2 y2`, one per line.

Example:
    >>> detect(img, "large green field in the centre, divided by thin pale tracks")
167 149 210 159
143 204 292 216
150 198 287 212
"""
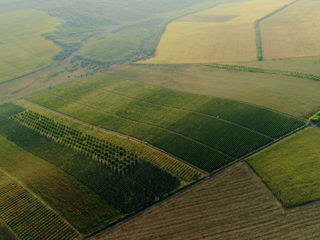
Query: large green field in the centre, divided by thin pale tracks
27 74 304 172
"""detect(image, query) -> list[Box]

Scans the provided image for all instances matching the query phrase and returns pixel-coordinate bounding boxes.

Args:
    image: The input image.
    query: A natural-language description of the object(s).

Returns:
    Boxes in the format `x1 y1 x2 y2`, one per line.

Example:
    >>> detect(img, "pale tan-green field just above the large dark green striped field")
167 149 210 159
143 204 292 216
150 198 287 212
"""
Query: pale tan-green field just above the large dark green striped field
107 64 320 118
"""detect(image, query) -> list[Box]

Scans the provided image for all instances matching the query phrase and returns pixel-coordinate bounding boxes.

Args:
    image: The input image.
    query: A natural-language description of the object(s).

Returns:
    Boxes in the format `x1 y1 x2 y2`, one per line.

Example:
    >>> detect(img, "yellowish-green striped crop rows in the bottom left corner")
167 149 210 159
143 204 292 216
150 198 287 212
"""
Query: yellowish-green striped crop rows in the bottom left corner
0 173 78 240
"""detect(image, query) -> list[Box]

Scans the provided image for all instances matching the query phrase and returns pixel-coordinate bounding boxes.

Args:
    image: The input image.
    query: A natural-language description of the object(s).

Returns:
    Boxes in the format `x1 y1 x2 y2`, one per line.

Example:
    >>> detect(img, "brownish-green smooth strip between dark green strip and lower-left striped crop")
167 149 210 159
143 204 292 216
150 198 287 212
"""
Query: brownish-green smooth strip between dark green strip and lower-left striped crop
0 137 121 234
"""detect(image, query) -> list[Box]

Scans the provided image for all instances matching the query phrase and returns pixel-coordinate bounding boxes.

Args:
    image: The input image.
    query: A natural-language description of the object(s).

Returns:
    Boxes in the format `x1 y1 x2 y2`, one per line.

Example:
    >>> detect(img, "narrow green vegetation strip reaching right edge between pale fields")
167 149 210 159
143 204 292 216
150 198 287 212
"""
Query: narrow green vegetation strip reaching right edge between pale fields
205 63 320 81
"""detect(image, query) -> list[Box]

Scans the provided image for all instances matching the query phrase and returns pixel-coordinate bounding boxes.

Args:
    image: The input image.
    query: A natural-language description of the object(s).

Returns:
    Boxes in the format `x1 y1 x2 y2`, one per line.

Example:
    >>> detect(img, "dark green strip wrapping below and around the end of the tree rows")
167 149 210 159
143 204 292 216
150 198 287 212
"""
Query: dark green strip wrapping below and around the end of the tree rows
0 104 180 214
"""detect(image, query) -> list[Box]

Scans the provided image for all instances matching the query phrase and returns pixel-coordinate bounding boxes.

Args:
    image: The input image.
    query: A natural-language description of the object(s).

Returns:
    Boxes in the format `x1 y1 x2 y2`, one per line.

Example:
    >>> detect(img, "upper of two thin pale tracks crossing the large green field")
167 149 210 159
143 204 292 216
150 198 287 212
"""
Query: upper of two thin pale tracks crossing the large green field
93 90 274 139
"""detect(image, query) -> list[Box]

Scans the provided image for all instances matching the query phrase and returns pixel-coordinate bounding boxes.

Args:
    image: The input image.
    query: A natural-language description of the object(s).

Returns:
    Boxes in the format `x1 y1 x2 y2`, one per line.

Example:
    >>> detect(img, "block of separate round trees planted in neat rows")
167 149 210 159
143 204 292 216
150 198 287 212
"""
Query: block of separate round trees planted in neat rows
12 110 138 174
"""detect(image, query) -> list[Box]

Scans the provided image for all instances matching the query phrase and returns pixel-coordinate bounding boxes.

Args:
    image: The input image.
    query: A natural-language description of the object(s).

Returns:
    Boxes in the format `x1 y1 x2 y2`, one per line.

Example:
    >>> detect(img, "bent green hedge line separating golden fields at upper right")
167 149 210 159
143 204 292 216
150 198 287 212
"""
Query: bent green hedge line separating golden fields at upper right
254 0 299 61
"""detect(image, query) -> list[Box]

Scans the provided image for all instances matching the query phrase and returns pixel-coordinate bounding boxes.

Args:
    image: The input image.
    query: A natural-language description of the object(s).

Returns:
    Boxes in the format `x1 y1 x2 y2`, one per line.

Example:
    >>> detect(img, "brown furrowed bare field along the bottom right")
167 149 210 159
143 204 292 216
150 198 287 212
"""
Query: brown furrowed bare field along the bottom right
92 162 320 240
